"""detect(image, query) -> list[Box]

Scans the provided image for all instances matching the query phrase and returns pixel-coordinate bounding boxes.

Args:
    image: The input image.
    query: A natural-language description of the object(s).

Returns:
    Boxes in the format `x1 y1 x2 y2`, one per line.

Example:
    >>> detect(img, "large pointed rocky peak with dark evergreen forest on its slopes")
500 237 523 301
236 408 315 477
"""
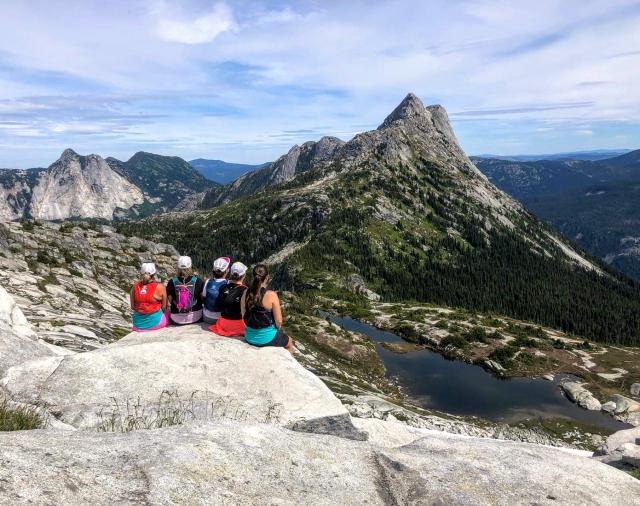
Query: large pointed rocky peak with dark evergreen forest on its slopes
120 94 640 344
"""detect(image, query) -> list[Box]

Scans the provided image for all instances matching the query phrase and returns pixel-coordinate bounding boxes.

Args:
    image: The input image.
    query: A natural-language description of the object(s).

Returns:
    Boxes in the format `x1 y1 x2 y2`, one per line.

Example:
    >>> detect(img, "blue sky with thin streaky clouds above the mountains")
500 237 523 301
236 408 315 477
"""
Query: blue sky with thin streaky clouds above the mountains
0 0 640 168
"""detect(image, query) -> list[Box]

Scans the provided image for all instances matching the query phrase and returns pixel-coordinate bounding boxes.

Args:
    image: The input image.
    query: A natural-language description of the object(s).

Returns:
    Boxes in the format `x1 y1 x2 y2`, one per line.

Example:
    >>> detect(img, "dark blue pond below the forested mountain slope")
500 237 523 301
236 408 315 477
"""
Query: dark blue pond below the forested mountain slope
330 313 629 430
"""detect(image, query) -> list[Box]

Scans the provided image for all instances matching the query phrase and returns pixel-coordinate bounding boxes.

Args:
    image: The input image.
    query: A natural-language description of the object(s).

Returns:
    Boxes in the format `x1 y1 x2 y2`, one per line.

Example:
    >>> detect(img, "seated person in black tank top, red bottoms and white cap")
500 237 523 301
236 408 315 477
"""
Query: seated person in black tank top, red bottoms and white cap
209 262 247 337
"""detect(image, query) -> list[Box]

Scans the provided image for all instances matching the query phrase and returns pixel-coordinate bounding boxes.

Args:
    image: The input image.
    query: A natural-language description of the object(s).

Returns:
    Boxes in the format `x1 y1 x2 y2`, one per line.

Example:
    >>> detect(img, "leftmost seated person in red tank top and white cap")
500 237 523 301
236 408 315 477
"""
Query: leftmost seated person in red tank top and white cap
129 263 169 332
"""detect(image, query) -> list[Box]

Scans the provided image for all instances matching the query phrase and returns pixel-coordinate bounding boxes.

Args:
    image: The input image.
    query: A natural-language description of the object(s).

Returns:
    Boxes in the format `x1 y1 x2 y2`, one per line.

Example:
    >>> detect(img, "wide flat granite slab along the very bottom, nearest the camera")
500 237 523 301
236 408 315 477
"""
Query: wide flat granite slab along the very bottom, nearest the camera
0 421 640 506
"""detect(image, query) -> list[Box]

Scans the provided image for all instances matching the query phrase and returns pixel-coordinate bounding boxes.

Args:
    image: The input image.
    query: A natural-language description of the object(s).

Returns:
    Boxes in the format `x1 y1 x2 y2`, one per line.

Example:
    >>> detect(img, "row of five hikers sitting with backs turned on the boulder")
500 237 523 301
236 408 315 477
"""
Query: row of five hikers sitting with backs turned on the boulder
130 256 293 353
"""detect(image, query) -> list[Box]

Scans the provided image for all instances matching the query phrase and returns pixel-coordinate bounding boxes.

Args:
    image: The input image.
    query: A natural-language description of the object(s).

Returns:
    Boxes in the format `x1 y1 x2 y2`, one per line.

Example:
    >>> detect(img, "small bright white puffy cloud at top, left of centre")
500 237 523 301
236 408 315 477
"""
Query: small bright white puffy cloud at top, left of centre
157 3 235 44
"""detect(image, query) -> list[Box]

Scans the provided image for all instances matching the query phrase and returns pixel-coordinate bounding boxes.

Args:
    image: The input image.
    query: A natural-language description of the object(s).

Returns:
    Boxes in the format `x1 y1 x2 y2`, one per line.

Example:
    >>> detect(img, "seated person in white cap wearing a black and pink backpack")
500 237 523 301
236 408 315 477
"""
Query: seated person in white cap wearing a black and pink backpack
167 256 204 325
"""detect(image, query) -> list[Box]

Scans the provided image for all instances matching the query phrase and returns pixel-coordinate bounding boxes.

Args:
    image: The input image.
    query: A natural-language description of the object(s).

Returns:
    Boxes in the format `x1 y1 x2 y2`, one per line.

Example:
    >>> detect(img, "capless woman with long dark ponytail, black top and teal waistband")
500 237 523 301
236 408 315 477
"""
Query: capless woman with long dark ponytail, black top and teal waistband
240 264 293 353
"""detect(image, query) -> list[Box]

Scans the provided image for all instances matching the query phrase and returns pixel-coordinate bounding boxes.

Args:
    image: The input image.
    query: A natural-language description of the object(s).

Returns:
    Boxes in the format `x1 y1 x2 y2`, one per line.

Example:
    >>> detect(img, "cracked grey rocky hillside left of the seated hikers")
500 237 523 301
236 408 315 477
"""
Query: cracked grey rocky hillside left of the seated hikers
0 222 178 351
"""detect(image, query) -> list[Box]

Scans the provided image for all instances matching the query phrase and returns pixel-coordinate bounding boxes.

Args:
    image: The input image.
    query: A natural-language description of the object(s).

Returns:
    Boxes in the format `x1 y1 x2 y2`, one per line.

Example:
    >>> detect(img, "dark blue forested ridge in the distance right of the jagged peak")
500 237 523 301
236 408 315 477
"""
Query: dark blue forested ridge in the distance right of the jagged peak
473 150 640 278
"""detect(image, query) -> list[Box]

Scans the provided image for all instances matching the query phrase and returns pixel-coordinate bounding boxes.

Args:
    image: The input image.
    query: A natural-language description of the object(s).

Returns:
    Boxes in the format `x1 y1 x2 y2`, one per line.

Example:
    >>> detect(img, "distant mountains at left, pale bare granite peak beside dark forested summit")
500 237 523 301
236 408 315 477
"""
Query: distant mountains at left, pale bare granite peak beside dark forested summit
0 149 215 221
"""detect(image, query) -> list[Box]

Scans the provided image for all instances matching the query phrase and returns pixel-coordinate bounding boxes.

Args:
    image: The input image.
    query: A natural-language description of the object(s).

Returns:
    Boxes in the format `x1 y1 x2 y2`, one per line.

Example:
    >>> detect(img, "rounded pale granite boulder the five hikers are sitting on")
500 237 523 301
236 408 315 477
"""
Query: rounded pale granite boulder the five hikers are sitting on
1 325 357 437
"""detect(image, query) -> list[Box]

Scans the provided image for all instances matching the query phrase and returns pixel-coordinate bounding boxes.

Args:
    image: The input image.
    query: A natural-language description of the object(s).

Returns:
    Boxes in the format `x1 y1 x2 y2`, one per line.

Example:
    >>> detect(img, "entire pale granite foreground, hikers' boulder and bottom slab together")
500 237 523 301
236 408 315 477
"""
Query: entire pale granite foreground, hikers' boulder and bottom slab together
0 322 640 505
